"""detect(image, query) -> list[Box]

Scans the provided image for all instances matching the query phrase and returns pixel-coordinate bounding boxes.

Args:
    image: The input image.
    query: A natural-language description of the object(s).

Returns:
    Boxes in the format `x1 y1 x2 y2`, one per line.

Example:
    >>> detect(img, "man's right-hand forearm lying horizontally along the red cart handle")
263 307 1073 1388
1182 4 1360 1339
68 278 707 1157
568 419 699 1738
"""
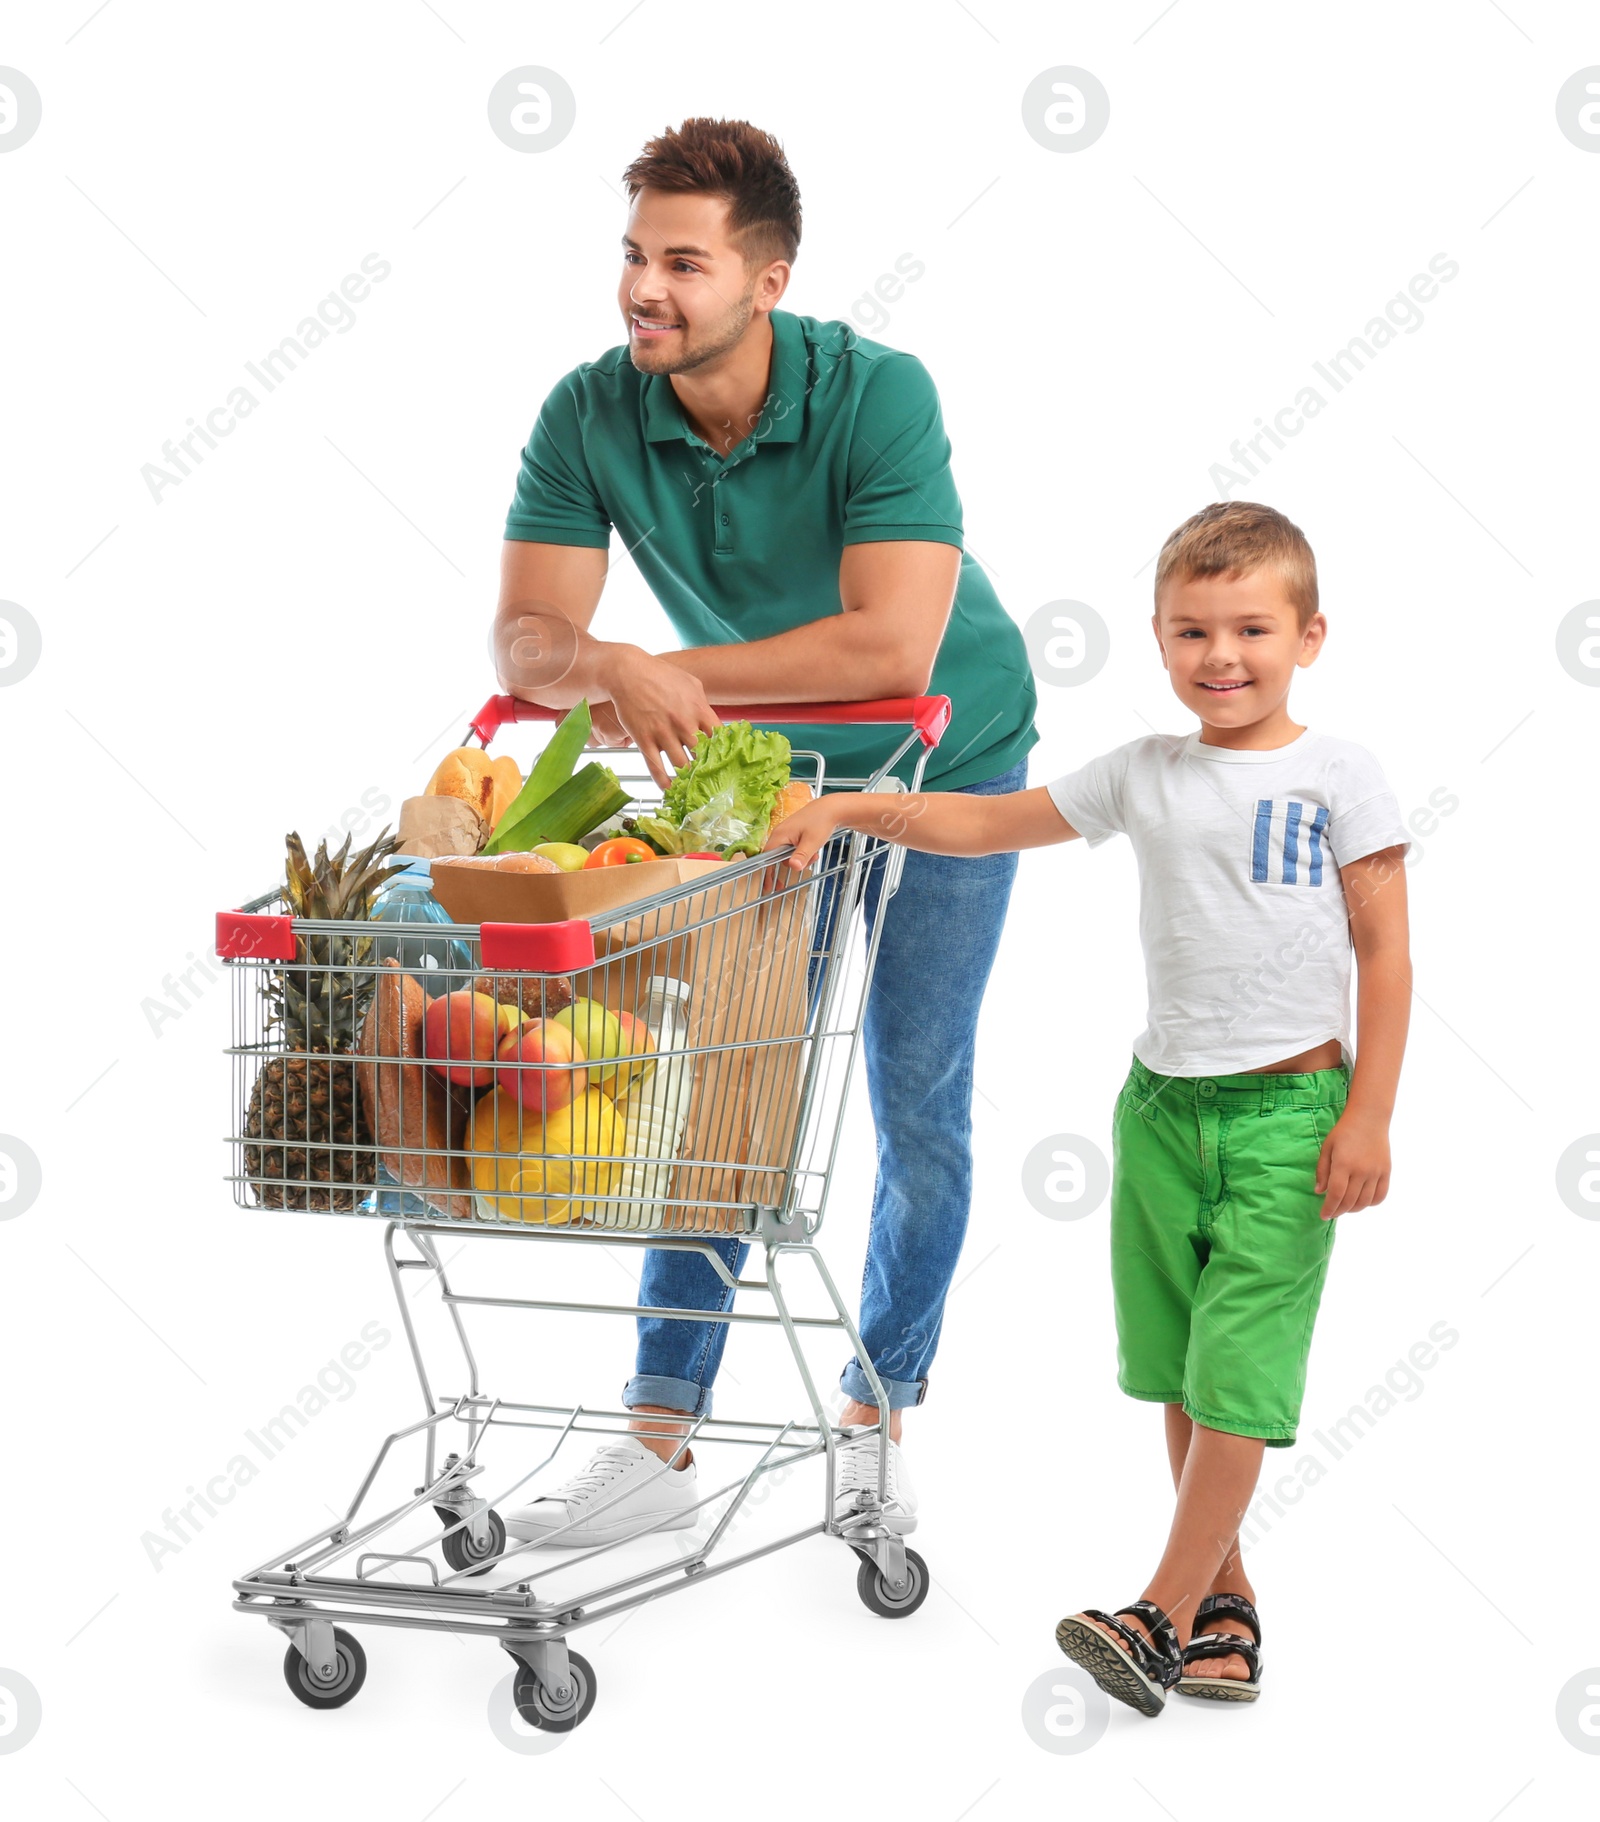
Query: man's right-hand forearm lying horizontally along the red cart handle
662 612 929 703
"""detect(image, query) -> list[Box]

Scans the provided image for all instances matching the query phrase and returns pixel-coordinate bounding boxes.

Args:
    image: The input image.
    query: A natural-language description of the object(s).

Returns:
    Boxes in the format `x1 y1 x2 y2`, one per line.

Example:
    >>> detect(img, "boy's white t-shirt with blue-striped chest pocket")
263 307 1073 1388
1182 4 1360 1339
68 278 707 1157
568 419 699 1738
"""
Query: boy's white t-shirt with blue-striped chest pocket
1048 729 1410 1075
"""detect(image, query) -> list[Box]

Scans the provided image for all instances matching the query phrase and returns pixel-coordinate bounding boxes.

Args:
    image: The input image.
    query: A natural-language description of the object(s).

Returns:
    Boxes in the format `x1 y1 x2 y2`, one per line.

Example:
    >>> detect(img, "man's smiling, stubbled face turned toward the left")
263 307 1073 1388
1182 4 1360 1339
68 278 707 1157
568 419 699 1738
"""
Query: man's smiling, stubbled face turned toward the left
618 189 789 374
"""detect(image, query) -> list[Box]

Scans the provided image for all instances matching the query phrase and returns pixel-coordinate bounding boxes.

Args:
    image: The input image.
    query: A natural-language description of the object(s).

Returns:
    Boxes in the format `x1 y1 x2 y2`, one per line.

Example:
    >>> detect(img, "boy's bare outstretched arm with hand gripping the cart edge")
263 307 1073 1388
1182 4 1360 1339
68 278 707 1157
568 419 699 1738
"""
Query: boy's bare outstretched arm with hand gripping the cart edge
767 785 1077 867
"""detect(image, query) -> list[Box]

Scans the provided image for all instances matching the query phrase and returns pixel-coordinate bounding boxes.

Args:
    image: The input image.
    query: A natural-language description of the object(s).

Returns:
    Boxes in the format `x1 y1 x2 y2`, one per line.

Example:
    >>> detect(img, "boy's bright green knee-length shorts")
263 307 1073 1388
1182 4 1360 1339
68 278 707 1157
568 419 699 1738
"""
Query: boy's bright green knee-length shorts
1112 1057 1350 1448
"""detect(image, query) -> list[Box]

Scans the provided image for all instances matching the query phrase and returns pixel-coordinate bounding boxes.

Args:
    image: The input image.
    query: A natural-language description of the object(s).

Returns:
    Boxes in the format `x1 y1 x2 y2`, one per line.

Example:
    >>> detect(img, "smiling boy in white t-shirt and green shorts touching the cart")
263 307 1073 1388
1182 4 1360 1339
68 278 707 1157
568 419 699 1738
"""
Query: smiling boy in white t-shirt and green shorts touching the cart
771 501 1410 1715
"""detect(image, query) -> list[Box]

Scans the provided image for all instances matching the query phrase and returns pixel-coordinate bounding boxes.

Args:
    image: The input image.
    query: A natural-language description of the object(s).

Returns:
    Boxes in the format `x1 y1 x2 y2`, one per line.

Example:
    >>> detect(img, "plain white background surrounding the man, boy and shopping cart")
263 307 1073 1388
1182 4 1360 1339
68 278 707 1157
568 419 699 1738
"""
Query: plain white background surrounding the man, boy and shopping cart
0 0 1600 1822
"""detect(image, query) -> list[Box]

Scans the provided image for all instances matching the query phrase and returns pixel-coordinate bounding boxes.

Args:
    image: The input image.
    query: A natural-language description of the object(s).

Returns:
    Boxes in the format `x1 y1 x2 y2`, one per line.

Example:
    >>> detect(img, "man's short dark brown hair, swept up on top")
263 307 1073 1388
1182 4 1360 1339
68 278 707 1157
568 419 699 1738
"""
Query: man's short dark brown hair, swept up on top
621 117 800 266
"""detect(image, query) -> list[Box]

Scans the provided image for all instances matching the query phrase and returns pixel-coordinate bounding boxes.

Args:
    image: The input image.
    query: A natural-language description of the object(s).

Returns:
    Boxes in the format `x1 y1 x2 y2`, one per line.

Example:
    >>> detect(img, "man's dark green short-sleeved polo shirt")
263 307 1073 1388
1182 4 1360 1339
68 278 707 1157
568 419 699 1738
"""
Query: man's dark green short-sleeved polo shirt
505 310 1039 791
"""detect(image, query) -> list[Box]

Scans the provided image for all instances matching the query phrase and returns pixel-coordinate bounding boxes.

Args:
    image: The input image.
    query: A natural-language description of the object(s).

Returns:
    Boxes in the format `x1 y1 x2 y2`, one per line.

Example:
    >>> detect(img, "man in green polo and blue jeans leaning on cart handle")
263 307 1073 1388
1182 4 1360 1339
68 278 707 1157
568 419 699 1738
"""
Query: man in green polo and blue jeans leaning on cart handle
494 120 1039 1545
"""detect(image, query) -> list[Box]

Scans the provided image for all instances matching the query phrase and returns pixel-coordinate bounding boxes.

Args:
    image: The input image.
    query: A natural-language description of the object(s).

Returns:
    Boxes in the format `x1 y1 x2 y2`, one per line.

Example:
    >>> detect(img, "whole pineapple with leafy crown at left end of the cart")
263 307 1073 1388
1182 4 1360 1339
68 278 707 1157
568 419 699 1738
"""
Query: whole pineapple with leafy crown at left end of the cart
244 829 403 1213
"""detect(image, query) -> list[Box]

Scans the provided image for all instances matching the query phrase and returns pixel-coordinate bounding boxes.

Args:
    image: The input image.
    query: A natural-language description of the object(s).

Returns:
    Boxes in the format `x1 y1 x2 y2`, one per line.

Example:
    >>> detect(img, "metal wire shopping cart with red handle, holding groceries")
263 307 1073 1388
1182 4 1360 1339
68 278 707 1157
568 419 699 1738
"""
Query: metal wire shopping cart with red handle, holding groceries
217 696 949 1731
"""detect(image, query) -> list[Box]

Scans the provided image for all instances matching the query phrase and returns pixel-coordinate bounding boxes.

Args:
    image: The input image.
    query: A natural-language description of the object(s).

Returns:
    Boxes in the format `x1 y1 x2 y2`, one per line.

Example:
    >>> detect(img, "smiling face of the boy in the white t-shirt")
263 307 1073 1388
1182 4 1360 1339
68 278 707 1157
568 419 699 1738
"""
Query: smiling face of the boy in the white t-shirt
1154 568 1328 727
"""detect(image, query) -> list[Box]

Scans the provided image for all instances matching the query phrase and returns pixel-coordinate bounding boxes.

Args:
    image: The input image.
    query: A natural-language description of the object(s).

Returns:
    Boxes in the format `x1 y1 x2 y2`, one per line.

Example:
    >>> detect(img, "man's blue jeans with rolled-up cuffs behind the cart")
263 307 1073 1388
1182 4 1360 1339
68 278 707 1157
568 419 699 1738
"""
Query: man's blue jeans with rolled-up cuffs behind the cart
621 758 1028 1416
